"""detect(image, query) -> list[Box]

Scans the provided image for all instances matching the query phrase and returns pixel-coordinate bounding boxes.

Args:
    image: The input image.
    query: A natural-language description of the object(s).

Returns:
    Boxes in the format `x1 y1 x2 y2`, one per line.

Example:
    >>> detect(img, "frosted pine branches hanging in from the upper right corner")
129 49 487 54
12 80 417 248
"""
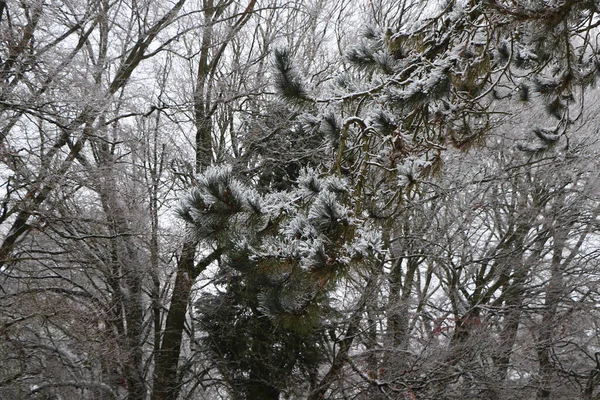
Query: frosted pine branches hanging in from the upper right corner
275 1 598 174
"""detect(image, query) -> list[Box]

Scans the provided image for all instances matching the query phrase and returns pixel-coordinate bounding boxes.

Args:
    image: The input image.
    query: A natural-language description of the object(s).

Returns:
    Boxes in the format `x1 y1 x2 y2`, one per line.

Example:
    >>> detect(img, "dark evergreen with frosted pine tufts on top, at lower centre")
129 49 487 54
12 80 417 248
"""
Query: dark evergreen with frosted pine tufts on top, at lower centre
179 167 381 399
